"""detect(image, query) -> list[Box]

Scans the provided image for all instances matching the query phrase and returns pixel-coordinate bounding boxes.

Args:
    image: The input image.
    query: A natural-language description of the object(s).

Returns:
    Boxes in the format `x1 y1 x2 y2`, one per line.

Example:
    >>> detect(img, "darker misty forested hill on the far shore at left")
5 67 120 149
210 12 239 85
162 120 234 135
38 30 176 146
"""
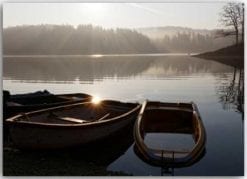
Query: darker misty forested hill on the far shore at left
3 25 158 54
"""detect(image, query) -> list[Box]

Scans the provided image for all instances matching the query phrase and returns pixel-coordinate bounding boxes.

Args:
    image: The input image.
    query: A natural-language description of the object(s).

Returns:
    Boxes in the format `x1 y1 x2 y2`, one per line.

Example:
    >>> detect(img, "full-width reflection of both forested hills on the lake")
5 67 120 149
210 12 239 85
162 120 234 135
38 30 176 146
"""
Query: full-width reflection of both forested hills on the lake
3 56 231 83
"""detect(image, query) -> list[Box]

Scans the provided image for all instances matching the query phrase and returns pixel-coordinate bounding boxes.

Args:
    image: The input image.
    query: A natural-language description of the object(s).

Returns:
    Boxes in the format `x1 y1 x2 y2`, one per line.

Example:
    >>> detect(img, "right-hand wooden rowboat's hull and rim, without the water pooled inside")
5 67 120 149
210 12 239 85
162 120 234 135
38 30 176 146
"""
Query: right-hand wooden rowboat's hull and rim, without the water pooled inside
134 101 206 167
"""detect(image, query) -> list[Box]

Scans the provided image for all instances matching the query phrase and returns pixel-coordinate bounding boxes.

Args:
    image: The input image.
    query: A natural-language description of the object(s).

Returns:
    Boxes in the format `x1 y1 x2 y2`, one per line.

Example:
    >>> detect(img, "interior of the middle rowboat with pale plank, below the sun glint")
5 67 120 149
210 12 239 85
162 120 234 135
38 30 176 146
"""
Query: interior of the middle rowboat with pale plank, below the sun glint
19 100 135 124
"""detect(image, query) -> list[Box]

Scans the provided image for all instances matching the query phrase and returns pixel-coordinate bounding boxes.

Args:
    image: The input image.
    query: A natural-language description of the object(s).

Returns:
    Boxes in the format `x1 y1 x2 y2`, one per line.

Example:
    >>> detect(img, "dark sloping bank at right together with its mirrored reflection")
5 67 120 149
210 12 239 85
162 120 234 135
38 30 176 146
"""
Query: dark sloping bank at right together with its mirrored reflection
194 44 244 68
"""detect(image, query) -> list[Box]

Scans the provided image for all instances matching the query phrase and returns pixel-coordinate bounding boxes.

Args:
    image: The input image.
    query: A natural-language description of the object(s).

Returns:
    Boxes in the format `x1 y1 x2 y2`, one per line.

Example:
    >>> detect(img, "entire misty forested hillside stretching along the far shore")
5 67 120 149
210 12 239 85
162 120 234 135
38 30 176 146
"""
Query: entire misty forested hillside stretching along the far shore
3 25 233 55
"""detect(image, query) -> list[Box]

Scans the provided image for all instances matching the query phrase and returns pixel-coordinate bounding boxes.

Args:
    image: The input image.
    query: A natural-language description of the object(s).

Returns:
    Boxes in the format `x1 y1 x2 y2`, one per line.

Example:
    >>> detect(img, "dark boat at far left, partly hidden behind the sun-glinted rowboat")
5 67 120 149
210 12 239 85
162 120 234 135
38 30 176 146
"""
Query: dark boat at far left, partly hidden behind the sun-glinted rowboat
4 90 92 118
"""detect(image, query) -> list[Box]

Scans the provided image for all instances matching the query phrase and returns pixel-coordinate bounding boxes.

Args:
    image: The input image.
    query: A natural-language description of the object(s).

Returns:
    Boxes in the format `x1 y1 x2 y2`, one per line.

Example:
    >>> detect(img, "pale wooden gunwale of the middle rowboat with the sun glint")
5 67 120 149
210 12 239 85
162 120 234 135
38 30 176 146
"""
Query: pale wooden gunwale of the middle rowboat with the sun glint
6 100 141 129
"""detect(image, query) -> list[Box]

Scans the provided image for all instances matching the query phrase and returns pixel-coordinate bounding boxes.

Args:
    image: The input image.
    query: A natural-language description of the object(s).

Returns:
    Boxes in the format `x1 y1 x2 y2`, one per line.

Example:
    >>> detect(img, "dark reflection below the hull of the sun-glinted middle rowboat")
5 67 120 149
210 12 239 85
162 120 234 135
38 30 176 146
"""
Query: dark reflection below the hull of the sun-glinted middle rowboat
68 119 137 167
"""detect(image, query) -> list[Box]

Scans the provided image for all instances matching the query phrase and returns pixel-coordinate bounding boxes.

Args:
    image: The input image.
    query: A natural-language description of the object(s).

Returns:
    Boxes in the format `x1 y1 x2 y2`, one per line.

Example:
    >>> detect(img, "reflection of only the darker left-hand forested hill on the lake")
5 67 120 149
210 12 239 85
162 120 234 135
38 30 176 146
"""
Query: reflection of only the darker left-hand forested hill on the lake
3 57 152 83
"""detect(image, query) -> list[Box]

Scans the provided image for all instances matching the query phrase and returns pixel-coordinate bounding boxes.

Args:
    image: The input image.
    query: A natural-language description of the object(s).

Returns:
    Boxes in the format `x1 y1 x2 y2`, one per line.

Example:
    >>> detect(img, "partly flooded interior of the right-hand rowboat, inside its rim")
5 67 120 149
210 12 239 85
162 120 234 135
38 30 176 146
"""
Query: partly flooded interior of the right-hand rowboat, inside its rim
140 105 198 157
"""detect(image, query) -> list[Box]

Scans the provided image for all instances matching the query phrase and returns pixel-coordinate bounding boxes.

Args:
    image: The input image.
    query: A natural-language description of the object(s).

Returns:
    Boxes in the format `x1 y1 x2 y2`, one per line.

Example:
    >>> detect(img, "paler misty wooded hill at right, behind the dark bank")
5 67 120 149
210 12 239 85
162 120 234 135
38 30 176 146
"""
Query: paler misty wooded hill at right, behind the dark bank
136 26 234 53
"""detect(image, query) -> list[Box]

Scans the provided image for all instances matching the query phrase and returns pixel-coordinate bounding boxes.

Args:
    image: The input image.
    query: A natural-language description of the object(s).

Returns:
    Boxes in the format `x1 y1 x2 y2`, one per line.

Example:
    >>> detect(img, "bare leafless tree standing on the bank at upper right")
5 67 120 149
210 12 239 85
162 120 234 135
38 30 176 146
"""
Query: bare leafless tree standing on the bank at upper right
220 3 244 44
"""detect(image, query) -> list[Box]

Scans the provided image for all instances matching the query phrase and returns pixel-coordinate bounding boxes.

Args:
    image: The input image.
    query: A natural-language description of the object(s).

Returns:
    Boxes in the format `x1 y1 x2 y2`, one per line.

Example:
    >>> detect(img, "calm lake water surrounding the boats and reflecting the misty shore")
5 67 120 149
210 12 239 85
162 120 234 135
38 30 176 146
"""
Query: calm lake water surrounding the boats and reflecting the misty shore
3 55 244 175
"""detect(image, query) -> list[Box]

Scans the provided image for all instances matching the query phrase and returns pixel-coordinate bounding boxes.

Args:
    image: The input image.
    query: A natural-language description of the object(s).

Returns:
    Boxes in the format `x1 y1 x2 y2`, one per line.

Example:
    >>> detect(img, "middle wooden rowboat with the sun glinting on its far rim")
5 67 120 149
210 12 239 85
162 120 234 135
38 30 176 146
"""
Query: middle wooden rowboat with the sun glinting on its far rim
6 100 141 149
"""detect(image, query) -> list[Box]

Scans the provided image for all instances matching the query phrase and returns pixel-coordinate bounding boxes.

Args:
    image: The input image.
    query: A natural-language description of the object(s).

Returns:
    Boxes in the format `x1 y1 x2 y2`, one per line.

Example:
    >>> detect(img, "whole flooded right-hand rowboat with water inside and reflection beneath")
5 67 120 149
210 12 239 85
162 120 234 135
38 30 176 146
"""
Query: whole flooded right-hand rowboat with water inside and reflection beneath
134 101 206 175
